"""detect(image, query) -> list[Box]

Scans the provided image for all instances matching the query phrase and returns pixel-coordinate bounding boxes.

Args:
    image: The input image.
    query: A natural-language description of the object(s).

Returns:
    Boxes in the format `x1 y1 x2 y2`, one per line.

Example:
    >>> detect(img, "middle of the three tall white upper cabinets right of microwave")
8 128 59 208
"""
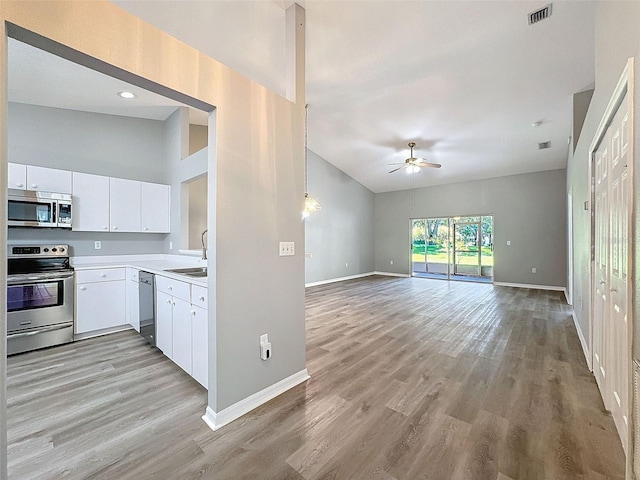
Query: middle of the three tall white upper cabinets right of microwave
109 178 141 232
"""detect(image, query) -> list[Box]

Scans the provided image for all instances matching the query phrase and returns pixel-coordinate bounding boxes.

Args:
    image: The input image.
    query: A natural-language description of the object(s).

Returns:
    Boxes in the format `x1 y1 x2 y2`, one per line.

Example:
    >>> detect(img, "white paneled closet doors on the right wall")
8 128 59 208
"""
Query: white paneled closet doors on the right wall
592 90 632 451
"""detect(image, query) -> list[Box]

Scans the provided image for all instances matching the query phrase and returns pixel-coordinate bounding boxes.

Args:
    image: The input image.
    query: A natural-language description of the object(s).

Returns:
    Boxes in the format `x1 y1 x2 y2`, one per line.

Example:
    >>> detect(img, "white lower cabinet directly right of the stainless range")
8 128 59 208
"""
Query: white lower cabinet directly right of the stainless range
75 268 127 334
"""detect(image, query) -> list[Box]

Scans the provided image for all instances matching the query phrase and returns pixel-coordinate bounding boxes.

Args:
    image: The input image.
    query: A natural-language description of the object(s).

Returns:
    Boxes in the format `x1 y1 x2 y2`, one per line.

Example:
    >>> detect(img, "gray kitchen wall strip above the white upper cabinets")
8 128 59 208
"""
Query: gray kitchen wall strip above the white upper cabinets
7 103 166 183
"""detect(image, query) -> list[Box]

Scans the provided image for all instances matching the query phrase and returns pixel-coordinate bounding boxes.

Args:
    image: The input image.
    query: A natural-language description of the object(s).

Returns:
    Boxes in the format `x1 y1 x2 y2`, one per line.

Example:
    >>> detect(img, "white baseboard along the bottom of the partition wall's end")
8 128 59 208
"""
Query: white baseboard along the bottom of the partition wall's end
202 368 311 430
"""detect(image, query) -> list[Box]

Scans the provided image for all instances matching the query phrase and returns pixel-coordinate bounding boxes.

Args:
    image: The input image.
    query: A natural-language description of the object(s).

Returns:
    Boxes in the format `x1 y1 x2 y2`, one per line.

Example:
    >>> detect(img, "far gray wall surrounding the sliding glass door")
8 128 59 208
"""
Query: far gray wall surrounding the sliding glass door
375 170 566 287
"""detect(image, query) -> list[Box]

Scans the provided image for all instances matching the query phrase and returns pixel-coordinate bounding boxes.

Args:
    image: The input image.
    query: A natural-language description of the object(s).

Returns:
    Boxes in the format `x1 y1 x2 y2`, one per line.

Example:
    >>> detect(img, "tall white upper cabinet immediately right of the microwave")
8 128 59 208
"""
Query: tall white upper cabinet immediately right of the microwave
73 172 109 232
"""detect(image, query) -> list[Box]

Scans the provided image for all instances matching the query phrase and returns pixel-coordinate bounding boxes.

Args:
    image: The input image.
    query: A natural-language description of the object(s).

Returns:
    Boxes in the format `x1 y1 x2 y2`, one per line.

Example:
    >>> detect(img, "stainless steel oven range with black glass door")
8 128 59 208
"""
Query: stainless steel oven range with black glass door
7 245 73 355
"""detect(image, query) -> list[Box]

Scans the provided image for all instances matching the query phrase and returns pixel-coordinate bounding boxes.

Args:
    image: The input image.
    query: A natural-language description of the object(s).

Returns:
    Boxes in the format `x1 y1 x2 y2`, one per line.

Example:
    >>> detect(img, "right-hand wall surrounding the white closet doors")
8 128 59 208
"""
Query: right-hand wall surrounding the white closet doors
567 2 640 355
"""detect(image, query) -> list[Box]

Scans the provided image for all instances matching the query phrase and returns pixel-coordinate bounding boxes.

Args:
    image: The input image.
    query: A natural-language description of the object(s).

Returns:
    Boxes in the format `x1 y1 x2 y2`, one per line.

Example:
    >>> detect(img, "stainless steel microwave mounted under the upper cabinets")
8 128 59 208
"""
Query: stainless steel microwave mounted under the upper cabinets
7 188 72 228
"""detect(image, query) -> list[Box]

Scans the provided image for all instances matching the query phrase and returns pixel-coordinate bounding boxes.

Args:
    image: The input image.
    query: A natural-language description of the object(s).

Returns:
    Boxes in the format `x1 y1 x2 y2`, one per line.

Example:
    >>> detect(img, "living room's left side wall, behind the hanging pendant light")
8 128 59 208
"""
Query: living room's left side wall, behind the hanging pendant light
305 151 375 283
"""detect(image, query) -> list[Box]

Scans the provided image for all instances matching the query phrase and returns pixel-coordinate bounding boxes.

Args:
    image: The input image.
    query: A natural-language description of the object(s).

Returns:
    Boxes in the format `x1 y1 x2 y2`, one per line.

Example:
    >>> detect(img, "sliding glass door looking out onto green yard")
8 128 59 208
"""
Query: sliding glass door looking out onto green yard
411 215 494 283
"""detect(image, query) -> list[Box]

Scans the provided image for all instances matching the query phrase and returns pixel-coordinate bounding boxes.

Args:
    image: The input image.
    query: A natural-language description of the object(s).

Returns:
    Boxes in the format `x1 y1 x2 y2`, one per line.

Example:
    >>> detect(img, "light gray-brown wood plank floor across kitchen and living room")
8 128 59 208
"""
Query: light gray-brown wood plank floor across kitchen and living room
8 277 624 480
